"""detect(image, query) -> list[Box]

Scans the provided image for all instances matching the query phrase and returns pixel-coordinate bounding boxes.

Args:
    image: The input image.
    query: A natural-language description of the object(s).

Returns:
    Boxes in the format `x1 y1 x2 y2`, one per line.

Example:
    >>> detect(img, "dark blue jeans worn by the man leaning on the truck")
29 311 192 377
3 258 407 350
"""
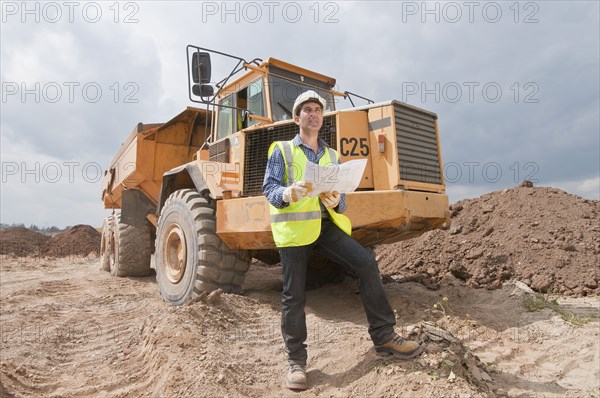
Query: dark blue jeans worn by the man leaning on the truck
279 220 396 366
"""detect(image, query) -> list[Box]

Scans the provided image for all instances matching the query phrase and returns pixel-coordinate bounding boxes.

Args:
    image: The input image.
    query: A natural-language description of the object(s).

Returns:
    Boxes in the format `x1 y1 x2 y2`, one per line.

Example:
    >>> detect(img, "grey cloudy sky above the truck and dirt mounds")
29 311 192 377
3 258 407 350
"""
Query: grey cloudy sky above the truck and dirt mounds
0 1 600 227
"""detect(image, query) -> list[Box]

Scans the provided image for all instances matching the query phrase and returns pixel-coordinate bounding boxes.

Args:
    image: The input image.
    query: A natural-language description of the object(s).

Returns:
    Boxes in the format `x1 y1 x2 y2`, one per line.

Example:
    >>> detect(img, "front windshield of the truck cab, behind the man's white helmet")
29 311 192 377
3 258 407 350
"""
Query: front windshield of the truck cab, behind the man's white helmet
269 74 335 122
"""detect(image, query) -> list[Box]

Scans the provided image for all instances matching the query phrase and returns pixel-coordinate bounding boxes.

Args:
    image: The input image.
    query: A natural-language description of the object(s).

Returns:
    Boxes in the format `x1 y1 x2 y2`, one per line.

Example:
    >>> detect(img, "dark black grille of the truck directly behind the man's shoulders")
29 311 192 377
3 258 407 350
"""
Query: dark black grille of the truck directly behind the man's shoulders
243 115 337 196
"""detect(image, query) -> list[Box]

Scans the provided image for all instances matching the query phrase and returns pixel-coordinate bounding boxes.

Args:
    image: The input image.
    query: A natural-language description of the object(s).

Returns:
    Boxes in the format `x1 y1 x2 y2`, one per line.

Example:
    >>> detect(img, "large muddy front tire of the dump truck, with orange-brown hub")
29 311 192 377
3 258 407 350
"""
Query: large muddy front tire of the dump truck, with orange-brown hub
154 189 250 305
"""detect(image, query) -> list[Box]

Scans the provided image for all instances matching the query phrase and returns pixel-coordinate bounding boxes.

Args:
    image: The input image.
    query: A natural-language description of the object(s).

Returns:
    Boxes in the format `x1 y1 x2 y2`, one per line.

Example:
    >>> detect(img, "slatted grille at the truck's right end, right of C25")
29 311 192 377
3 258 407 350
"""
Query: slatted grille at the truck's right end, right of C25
394 102 442 184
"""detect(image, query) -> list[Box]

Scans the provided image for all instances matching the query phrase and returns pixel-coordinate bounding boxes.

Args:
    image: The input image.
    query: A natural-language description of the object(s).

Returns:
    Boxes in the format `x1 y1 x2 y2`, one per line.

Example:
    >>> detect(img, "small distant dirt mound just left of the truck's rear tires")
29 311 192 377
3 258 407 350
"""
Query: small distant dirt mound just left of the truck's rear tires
43 224 101 257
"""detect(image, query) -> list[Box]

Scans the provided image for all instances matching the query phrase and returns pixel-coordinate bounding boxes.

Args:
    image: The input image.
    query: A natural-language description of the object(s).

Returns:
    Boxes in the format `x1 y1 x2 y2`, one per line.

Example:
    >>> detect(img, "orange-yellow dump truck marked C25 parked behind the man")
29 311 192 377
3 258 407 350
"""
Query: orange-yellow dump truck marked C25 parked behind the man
101 45 449 305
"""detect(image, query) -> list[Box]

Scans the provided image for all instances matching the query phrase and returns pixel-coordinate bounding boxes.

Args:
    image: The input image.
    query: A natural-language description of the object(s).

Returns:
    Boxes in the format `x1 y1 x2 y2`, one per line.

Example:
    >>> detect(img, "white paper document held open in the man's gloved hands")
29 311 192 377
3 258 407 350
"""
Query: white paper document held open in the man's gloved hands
304 159 367 198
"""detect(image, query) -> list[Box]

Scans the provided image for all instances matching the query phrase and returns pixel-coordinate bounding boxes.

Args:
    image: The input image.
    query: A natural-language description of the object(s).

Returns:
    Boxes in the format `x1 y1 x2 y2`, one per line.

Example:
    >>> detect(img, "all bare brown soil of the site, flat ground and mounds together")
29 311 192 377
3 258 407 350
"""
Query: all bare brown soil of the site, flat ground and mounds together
0 187 600 398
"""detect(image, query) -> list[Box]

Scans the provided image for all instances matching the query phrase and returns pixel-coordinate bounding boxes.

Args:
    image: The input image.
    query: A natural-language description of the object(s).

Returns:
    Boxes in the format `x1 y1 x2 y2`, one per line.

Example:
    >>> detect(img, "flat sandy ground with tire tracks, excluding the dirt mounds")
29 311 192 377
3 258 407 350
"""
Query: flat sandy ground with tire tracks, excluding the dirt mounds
0 256 600 397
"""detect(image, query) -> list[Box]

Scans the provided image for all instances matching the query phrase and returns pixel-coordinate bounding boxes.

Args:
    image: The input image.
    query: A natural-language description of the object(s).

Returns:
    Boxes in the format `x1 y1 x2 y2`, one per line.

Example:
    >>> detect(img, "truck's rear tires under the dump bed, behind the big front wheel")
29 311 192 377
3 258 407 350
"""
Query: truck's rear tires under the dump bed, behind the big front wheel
109 212 152 277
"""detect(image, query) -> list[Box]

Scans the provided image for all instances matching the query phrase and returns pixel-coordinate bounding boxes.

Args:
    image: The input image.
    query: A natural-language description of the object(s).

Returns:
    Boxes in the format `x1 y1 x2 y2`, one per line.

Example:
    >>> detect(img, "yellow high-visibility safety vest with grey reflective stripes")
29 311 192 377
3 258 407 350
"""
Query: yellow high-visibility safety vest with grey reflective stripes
269 141 352 247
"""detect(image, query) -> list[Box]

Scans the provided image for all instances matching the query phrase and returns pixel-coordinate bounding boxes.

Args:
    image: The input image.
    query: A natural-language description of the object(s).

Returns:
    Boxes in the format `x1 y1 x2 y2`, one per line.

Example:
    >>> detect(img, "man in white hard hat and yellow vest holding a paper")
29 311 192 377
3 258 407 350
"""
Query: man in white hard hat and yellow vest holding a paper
263 90 423 390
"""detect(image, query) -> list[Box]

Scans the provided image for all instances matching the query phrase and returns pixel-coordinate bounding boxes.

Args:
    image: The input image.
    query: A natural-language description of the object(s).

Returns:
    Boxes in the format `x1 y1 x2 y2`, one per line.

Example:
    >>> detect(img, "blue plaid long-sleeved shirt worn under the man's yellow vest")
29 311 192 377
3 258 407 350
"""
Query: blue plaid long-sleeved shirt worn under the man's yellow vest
263 134 348 217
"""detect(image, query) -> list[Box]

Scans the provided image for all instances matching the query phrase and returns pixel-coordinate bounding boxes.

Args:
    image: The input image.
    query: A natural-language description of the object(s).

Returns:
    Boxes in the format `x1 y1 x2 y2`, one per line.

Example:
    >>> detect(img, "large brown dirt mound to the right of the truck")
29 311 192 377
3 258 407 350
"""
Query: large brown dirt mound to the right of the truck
376 185 600 296
